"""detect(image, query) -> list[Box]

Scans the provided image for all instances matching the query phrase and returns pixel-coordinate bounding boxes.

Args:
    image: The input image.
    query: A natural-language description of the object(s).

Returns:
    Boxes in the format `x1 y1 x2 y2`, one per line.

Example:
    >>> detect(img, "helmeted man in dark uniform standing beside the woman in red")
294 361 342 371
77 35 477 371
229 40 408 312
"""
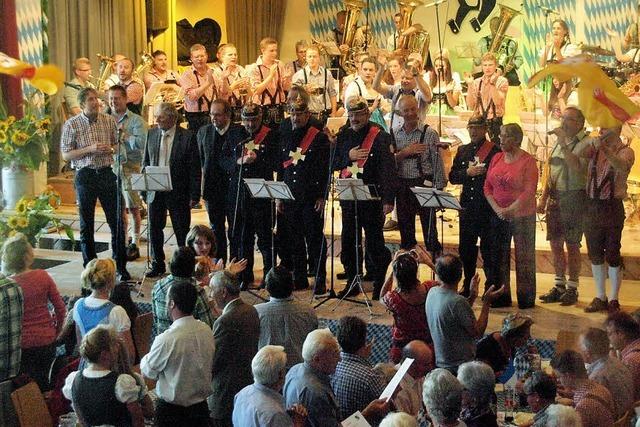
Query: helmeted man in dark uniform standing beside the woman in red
449 116 500 296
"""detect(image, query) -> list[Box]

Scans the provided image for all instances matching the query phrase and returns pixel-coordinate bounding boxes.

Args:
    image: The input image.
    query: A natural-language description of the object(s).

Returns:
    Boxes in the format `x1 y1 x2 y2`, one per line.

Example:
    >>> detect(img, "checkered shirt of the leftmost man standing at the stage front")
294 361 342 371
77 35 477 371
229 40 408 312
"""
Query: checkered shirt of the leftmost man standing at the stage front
60 113 117 170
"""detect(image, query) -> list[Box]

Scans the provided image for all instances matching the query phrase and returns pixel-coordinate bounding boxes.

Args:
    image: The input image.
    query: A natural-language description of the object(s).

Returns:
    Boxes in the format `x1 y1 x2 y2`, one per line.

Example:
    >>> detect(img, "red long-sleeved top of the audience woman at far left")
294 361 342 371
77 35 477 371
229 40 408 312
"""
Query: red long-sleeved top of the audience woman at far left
12 270 67 348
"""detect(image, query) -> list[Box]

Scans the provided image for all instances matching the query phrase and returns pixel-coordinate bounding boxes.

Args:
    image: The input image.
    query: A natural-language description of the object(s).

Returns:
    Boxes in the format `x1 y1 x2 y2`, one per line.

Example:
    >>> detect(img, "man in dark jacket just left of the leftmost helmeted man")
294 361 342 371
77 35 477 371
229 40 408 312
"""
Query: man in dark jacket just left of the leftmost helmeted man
196 99 244 262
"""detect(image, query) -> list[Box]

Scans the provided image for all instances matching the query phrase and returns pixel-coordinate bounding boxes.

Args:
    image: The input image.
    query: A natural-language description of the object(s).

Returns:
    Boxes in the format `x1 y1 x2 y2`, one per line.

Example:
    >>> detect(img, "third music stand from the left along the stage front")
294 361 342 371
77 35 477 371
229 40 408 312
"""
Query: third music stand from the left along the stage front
331 178 380 316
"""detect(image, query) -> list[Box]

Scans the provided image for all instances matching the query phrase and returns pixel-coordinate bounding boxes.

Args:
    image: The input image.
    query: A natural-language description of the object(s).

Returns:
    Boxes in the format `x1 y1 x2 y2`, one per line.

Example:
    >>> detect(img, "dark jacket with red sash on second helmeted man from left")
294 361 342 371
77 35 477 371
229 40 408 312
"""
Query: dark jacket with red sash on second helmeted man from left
278 120 329 202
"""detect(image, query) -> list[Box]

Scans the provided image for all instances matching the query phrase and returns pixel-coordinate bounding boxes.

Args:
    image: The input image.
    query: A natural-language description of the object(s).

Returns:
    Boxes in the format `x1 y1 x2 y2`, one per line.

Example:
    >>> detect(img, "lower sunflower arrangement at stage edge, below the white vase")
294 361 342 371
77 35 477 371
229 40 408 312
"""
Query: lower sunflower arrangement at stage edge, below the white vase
0 185 74 247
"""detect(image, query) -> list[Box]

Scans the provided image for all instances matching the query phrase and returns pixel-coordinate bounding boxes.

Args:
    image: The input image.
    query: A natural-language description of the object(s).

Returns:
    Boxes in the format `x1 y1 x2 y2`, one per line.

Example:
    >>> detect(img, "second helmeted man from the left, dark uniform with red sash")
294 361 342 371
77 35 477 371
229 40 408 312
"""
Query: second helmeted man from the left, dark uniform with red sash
276 98 329 294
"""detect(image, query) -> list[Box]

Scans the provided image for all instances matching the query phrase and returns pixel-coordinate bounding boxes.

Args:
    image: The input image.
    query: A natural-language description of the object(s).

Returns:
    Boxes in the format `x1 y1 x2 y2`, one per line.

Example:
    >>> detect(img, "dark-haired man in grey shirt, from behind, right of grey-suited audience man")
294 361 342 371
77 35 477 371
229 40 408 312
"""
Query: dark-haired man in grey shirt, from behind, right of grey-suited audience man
255 266 318 368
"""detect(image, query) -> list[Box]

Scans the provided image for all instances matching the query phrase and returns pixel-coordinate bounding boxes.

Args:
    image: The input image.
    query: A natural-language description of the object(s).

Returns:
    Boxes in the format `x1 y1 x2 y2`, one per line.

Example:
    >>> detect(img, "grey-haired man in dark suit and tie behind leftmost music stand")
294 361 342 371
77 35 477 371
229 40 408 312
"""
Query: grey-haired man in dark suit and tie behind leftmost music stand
142 102 201 277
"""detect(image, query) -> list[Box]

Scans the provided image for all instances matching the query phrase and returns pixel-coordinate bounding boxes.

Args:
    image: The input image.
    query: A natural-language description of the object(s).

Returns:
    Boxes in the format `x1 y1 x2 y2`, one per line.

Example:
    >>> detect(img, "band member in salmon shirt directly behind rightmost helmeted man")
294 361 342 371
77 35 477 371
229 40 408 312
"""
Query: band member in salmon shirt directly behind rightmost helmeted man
467 52 509 143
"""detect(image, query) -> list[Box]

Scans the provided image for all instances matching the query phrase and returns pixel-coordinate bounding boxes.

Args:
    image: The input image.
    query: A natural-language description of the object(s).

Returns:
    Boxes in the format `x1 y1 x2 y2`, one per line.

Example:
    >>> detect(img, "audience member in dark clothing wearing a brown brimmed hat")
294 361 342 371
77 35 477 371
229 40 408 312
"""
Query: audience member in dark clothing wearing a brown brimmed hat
476 313 533 377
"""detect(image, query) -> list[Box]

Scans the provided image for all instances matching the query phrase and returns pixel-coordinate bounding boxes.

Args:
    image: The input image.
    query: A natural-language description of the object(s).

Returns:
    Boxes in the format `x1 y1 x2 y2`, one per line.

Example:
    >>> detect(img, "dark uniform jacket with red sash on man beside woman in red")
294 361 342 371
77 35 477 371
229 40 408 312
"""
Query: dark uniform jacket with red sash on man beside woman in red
449 137 500 211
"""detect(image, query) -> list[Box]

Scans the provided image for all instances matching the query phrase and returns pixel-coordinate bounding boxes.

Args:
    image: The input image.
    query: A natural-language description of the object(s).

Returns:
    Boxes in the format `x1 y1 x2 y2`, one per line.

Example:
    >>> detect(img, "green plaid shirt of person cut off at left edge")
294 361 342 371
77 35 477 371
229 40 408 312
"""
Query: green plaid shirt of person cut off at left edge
0 274 23 382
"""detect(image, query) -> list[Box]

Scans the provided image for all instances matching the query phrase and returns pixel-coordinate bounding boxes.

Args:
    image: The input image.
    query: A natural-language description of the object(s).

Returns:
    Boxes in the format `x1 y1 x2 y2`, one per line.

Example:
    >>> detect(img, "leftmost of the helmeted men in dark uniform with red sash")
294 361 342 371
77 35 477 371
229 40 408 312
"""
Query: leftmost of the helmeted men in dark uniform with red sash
221 103 278 288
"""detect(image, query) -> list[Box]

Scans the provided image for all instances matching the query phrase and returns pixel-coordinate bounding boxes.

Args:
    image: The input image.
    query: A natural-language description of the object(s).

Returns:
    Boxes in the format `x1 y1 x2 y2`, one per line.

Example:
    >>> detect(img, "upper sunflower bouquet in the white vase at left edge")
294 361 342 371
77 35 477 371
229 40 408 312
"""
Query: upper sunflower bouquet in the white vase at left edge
0 92 51 171
